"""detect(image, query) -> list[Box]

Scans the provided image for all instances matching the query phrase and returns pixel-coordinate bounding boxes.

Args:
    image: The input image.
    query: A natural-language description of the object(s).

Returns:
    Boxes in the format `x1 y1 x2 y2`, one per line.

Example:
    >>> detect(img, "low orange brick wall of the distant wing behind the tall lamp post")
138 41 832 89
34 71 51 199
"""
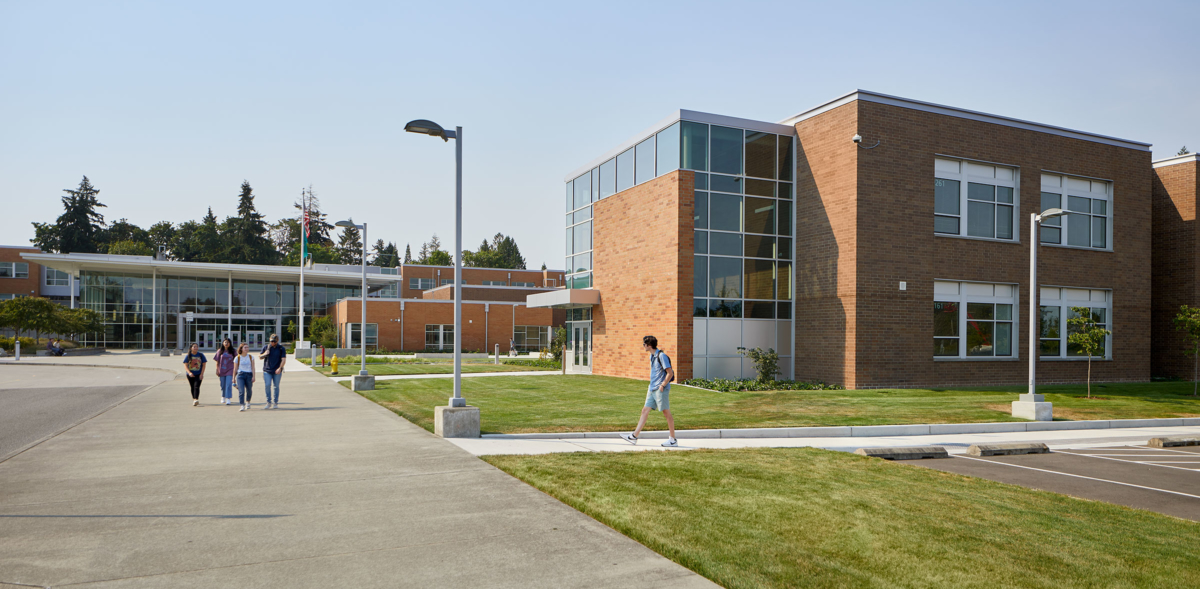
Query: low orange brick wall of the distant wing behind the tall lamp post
332 299 552 353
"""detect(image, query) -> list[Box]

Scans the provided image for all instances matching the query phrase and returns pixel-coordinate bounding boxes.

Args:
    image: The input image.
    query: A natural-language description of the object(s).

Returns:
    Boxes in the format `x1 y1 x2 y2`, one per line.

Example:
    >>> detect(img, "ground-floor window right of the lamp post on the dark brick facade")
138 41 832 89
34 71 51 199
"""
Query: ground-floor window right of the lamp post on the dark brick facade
1038 286 1112 359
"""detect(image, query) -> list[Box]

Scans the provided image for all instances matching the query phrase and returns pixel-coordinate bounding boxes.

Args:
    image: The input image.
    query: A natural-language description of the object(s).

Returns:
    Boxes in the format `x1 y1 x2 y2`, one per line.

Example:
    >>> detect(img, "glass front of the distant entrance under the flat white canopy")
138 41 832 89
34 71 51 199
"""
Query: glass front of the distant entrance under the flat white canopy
79 271 360 349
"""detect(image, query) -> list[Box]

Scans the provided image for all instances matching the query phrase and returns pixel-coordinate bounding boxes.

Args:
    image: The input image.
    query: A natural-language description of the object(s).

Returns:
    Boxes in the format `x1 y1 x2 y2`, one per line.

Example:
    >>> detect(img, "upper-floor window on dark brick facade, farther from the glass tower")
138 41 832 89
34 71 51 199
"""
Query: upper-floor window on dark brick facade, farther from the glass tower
1042 174 1112 250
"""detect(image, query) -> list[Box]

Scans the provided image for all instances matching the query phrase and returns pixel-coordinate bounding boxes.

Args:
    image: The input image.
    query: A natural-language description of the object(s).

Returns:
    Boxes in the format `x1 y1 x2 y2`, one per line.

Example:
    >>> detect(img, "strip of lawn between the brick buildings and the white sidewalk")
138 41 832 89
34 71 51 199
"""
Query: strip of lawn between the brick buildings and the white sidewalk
346 372 1200 433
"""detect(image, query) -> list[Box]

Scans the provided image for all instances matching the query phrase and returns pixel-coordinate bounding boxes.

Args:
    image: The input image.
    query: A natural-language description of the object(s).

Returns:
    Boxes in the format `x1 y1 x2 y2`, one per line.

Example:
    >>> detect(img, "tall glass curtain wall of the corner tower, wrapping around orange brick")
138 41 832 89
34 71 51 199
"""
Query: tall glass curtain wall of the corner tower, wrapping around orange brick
566 115 796 378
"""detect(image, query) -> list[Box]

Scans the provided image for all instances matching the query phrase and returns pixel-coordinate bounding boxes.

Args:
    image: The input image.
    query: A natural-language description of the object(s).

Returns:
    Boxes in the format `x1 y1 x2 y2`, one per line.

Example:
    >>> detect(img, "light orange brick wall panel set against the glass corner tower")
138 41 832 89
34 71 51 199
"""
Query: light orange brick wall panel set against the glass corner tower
592 170 696 380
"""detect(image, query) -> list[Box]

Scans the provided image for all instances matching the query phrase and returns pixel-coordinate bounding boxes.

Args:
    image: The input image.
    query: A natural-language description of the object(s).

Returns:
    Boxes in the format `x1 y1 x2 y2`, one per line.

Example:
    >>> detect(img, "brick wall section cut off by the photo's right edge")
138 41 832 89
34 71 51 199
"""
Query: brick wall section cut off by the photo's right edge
1151 160 1200 379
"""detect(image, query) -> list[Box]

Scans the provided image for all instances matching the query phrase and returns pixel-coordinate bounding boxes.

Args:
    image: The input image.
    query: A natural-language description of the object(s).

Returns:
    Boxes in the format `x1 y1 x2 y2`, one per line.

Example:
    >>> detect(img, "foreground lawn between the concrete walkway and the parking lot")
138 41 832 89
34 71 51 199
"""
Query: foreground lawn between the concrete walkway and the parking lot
482 448 1200 589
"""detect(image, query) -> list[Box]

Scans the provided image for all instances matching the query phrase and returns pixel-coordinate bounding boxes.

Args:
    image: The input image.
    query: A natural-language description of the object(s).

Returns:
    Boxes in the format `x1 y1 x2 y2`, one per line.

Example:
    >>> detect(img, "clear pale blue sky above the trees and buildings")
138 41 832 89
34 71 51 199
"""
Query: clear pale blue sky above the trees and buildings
0 0 1200 268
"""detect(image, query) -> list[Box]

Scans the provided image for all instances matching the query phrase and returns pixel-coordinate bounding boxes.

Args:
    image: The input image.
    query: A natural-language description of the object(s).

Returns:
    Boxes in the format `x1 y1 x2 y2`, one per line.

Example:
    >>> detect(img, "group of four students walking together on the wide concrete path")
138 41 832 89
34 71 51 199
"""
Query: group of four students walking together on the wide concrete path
184 333 288 411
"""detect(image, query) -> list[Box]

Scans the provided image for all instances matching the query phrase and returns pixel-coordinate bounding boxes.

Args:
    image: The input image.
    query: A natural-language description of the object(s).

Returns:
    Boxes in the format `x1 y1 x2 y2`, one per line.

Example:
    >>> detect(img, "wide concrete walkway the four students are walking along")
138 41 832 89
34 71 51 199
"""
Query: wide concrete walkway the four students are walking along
0 354 715 588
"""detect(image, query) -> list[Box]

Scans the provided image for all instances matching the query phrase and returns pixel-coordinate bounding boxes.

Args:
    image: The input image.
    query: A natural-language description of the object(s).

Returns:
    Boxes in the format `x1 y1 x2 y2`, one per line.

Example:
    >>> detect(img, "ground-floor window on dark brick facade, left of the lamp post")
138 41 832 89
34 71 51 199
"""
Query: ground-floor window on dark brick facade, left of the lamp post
934 282 1016 359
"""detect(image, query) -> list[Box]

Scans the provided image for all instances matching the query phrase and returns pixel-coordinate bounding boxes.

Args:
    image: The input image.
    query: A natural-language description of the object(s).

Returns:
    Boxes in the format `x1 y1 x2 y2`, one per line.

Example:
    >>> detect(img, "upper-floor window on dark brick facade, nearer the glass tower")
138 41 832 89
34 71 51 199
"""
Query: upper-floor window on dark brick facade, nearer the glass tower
934 157 1018 240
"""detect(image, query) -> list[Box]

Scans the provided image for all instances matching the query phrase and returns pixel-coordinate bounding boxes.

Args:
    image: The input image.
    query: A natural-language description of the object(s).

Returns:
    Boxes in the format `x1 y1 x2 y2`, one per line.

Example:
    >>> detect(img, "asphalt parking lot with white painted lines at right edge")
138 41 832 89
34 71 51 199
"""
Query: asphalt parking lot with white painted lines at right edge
910 445 1200 522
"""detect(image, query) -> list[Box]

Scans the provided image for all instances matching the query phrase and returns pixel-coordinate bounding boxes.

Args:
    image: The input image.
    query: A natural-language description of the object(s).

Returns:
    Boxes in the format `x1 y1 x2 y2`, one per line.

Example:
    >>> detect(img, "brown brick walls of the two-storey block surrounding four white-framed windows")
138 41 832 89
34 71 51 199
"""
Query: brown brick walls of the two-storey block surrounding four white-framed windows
797 101 1151 387
